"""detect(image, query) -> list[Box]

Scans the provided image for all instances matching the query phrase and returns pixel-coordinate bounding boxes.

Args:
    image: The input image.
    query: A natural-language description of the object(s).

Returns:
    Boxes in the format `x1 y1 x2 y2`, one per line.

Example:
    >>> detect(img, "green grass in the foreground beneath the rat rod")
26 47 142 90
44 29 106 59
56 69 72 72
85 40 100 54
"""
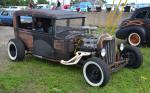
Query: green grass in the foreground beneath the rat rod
0 48 150 93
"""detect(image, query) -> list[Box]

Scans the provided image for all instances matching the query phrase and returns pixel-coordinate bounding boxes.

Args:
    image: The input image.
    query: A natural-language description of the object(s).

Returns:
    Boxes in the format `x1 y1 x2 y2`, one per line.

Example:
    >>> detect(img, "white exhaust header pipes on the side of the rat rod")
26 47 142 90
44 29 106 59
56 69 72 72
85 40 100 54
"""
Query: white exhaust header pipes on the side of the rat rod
60 51 91 65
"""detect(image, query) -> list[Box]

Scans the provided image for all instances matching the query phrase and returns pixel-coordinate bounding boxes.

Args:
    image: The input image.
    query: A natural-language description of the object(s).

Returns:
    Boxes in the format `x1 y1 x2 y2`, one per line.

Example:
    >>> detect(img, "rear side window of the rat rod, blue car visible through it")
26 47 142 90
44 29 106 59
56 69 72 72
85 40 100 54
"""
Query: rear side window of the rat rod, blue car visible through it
18 16 32 30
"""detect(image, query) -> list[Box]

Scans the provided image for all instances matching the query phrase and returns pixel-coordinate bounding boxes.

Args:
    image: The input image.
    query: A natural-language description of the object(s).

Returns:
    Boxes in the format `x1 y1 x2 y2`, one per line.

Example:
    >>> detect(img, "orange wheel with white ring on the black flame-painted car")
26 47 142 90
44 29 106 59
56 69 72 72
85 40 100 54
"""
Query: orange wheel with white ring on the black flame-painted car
128 33 141 46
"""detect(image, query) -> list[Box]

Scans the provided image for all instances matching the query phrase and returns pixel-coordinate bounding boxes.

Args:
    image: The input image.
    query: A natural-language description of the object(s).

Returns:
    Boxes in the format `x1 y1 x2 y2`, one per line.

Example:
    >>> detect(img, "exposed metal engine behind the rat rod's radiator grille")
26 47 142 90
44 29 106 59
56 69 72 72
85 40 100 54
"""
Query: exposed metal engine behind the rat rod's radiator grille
67 27 98 52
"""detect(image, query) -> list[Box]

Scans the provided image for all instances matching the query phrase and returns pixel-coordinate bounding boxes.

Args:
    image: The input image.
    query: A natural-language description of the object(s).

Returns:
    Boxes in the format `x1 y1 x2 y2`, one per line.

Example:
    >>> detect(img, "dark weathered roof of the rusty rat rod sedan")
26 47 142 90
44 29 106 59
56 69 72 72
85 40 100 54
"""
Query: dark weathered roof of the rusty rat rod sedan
15 9 85 19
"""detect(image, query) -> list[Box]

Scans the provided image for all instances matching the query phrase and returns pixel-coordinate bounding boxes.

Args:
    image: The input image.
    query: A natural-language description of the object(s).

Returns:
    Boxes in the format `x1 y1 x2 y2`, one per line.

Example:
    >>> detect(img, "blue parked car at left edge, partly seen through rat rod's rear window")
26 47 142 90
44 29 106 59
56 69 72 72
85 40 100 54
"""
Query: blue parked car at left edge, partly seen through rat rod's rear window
0 10 31 26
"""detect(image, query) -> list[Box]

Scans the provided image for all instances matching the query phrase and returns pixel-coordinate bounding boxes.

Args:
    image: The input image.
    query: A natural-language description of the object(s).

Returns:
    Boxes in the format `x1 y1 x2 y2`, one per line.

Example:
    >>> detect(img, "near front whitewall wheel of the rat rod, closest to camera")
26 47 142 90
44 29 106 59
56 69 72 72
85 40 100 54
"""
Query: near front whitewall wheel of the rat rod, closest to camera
83 57 110 87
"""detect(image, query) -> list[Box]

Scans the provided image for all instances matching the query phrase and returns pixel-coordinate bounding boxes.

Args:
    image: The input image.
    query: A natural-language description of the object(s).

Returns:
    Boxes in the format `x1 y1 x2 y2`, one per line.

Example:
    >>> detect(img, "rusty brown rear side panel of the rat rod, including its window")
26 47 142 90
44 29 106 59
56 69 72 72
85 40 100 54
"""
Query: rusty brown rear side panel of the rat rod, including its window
14 15 33 51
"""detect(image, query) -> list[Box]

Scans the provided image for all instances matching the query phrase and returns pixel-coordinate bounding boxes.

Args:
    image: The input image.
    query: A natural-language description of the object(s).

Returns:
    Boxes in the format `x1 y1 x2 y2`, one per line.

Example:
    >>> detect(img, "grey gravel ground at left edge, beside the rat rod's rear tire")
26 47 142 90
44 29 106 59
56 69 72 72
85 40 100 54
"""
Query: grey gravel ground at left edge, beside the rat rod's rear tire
0 26 14 63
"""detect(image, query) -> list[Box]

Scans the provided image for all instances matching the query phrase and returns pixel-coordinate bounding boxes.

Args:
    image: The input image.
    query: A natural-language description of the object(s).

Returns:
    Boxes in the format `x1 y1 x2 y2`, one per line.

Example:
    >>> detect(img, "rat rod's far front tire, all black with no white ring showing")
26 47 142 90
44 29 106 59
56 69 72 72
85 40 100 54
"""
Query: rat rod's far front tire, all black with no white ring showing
121 46 143 69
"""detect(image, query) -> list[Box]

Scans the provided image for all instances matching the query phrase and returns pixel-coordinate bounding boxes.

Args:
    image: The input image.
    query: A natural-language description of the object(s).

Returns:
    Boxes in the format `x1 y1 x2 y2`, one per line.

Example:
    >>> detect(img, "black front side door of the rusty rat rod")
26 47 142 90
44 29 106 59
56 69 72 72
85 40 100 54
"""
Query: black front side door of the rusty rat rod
33 18 54 58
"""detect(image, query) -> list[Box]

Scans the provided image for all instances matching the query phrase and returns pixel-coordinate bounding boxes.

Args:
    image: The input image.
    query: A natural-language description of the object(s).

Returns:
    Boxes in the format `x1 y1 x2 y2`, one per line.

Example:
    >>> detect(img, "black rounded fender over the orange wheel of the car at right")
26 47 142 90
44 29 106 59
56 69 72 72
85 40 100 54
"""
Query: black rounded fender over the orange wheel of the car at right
116 26 146 41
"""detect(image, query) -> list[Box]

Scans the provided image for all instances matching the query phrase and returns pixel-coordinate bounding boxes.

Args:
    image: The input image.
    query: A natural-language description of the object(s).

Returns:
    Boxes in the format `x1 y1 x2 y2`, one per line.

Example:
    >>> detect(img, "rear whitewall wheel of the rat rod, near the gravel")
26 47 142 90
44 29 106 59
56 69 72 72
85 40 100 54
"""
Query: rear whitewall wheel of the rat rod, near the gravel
7 39 25 61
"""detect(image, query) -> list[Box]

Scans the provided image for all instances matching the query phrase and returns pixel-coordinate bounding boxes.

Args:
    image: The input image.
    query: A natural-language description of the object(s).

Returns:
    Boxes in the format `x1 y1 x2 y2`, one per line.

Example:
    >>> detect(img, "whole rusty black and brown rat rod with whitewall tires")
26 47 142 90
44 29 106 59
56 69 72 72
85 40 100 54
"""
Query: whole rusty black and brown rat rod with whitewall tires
7 9 143 86
